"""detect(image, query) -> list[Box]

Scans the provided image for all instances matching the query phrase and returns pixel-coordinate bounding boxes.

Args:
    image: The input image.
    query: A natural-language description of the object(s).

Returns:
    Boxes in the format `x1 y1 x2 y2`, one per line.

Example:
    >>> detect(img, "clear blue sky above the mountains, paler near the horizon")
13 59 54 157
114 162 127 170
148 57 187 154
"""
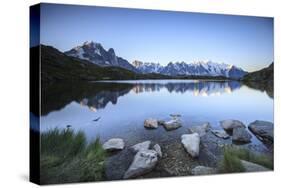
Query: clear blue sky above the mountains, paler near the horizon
38 4 273 71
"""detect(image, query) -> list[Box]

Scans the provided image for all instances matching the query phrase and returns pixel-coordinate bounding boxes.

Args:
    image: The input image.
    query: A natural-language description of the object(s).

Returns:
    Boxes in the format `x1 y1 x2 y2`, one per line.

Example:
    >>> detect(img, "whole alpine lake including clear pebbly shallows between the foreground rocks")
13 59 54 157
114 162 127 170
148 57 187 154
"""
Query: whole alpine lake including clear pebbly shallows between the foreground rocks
40 80 274 180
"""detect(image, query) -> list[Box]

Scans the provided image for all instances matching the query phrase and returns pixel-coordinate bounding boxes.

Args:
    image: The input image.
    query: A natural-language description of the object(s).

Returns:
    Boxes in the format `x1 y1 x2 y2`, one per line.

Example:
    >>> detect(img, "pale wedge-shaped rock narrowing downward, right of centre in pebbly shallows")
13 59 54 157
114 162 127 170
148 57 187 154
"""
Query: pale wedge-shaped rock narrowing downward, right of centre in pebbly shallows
181 133 200 157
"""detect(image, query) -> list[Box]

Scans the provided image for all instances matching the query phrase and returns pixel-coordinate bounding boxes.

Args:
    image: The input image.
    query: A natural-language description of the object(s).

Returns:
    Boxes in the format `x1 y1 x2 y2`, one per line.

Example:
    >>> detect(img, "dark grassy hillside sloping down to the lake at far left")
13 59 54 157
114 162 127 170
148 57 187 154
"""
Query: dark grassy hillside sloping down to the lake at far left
30 45 135 83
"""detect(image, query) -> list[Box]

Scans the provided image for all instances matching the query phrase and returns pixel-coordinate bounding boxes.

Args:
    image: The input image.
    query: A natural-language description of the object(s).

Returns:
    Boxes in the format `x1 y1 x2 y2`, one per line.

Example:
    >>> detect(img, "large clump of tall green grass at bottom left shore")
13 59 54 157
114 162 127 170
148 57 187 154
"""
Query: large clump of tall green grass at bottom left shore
40 129 106 184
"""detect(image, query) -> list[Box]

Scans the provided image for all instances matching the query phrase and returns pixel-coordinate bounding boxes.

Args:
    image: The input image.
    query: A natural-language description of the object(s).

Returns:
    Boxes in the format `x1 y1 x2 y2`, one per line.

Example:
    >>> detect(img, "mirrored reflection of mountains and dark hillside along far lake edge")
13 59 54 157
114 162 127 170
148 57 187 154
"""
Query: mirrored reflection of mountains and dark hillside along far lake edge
42 80 247 115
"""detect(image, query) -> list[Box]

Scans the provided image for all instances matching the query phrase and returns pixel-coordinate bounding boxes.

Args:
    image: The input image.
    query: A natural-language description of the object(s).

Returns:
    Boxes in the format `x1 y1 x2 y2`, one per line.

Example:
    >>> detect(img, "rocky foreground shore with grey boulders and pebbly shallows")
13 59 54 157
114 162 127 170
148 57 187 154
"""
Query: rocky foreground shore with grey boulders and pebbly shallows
103 114 274 179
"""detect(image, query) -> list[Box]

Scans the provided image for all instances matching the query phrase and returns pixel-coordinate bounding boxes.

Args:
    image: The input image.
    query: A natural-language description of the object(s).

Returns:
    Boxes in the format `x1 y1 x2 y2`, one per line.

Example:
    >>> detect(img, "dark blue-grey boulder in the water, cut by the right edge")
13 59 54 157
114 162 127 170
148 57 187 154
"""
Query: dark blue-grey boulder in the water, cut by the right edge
248 120 274 143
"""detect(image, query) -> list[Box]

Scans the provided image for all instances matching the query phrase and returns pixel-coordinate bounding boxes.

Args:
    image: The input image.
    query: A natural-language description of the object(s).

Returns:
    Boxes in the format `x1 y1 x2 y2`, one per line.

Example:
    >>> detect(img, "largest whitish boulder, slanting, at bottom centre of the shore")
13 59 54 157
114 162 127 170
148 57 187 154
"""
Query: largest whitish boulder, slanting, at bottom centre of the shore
123 150 158 179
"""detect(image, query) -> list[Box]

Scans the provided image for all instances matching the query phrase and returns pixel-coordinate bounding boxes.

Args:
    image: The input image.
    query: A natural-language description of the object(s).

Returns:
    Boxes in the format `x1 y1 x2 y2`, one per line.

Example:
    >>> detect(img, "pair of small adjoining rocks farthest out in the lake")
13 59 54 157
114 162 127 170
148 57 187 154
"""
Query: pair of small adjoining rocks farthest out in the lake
144 114 182 131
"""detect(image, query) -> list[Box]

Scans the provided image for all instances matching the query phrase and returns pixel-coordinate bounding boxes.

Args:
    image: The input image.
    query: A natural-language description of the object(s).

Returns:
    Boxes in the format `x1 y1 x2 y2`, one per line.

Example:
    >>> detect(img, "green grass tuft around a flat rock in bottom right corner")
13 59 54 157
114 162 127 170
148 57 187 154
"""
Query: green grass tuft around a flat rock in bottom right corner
219 147 273 173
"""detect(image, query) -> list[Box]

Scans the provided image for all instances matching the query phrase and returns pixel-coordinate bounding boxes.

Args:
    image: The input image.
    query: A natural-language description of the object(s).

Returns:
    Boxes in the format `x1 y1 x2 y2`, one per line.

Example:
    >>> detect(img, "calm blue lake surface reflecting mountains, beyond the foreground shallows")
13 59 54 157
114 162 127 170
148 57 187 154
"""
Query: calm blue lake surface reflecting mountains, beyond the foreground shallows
41 80 273 145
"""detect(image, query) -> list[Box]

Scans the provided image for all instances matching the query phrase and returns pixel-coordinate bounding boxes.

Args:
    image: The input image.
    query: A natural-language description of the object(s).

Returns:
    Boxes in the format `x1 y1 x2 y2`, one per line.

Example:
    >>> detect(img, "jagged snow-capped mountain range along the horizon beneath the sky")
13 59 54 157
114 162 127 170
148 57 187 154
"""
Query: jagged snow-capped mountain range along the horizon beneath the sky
64 41 247 79
